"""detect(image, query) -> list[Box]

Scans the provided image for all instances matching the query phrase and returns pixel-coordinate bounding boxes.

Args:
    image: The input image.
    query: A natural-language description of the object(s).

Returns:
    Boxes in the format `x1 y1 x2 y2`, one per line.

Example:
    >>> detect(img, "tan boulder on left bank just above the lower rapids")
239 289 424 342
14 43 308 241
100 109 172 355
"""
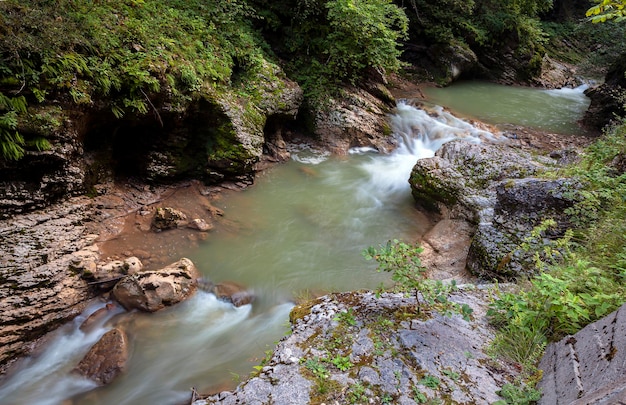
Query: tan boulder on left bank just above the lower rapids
113 258 199 312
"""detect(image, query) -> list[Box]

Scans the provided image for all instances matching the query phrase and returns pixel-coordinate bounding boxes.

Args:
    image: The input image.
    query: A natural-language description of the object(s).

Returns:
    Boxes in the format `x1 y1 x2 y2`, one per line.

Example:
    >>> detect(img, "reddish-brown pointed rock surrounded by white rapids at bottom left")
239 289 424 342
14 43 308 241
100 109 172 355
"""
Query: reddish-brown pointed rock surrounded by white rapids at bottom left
74 329 128 385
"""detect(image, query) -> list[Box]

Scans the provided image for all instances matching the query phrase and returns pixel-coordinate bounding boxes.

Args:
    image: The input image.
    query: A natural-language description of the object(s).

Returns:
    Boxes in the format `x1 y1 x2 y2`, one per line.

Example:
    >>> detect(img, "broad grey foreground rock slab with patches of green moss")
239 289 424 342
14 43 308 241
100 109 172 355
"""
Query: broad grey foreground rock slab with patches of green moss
194 291 515 405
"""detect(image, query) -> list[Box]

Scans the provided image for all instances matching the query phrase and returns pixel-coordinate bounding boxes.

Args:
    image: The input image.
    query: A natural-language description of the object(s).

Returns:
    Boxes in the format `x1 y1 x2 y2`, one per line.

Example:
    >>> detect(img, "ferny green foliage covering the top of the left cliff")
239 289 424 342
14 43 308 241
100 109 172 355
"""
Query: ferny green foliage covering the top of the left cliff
0 0 263 128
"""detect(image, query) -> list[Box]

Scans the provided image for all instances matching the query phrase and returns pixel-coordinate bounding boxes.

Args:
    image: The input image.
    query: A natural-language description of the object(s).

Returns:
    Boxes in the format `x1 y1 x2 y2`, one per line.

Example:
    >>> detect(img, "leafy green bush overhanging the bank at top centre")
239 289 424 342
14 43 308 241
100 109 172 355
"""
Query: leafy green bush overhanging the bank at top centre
253 0 408 103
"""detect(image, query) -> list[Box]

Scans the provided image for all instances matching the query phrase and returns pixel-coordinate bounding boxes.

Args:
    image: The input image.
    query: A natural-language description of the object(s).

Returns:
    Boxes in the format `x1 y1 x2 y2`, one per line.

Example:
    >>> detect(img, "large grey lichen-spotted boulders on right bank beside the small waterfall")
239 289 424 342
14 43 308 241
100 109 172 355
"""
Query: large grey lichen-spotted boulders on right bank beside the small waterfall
409 141 578 279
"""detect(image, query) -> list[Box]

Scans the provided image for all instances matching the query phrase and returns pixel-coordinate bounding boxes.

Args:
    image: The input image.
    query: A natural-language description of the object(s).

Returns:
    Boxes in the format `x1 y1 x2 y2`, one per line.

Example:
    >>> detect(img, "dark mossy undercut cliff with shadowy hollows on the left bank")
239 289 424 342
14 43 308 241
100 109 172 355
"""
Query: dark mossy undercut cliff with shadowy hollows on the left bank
0 63 302 218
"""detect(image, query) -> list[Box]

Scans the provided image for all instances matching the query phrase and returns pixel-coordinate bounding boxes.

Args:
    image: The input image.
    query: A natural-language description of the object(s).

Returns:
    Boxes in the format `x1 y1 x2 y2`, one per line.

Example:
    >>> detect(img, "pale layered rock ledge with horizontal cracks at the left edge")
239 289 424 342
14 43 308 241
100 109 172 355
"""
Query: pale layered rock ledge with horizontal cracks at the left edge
0 198 99 372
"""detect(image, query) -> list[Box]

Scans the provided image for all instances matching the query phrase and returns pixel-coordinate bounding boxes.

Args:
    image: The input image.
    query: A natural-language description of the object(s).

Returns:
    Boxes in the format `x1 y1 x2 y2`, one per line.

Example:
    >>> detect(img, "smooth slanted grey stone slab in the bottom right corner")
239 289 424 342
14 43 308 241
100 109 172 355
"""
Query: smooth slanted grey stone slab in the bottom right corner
538 306 626 405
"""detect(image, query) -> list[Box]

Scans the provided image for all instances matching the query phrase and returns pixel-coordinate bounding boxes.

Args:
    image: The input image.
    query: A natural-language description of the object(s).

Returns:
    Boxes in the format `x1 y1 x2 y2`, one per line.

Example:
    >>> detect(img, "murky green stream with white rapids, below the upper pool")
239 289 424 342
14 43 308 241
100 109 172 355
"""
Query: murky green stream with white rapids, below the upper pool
0 84 584 405
